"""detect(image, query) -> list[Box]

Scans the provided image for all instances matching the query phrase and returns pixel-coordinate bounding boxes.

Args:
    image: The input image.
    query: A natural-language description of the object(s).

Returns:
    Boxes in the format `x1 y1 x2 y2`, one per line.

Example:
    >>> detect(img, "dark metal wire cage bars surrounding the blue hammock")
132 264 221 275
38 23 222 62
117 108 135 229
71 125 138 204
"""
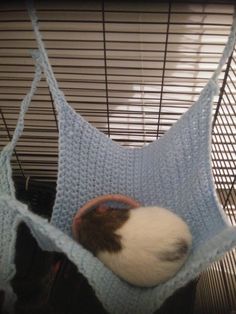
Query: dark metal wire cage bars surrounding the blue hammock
0 1 236 314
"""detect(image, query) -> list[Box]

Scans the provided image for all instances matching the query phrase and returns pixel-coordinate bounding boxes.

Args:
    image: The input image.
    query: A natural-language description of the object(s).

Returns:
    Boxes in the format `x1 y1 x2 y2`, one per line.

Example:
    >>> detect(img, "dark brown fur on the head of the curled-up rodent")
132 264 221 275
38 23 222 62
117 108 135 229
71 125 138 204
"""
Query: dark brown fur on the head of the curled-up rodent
77 205 130 255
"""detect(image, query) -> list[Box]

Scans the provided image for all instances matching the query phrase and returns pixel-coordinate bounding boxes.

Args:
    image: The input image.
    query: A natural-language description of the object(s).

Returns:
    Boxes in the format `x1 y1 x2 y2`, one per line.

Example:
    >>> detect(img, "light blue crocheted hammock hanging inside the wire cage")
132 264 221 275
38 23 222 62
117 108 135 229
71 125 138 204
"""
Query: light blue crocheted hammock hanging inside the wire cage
0 3 236 314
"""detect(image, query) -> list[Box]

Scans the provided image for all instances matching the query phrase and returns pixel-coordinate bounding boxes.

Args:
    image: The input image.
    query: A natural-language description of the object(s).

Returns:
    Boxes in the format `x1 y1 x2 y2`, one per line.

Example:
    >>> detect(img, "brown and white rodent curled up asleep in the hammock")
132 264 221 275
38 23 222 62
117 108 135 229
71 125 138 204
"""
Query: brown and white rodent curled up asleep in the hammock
72 195 192 287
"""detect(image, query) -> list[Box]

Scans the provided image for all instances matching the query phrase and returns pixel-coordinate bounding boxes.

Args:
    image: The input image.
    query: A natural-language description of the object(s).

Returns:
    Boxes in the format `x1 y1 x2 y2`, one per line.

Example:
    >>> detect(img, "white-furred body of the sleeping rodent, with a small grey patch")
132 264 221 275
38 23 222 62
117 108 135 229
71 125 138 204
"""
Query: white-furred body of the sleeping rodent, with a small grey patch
98 207 192 287
